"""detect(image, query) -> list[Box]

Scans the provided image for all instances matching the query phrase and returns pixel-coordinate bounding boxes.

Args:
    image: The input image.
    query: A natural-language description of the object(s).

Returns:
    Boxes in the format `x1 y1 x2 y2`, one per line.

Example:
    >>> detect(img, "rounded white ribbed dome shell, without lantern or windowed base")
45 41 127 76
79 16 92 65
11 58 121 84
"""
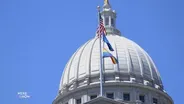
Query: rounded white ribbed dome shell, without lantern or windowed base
60 35 163 93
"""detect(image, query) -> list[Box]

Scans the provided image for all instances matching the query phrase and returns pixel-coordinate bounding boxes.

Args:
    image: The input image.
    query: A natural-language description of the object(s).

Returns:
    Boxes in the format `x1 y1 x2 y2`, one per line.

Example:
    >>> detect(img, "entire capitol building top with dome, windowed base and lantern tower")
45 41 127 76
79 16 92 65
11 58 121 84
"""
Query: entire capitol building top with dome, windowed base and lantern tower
53 0 174 104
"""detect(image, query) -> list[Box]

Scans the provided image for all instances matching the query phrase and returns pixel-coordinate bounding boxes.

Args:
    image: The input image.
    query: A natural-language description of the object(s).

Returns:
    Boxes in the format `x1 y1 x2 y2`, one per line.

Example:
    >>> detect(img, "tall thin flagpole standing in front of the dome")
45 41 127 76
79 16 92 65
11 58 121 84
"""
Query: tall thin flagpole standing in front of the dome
97 6 103 96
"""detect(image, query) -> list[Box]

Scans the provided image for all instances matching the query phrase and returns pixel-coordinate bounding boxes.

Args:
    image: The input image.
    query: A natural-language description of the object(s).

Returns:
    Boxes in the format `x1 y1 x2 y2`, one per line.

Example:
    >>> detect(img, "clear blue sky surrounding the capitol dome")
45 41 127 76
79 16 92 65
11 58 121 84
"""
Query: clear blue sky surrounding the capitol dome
0 0 184 104
